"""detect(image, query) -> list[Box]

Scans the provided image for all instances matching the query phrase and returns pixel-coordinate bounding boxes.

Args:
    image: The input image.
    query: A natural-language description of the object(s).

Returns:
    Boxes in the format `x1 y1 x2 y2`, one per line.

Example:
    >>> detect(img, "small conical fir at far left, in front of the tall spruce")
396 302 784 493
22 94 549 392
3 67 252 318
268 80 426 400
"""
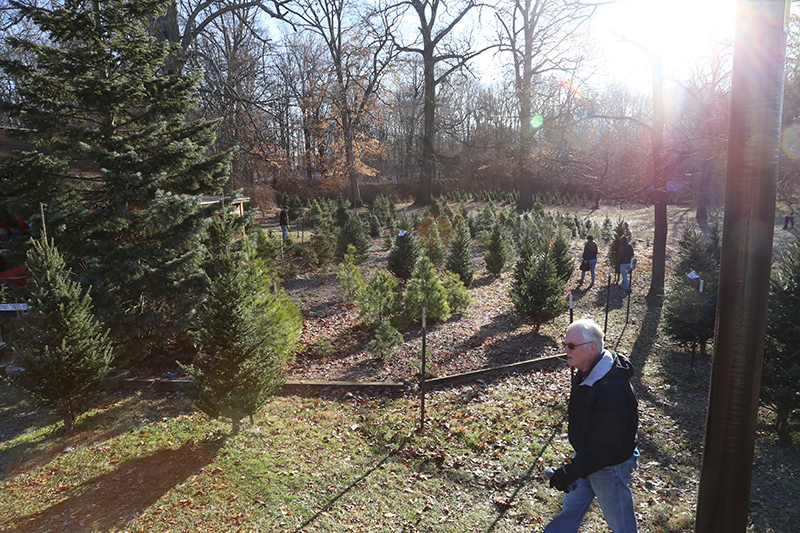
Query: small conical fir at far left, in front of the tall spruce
10 220 113 433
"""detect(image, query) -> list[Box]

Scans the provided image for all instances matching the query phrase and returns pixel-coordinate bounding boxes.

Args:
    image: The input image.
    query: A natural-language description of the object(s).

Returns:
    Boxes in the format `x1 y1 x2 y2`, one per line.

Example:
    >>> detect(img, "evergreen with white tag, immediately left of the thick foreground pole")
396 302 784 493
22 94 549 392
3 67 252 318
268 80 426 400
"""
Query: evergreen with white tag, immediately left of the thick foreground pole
664 226 721 353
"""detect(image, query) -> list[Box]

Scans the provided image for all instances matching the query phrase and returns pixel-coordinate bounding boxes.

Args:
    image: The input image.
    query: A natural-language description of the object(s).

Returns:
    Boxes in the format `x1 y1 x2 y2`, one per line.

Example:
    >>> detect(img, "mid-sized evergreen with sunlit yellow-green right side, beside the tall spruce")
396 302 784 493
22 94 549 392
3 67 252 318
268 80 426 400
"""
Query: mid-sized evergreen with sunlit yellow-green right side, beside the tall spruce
183 217 302 434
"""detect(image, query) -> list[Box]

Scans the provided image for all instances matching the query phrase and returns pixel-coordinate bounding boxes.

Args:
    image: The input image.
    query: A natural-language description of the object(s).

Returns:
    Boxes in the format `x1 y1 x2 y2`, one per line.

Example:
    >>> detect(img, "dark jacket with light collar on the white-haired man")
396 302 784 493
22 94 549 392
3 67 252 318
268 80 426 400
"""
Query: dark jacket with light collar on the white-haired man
565 350 639 483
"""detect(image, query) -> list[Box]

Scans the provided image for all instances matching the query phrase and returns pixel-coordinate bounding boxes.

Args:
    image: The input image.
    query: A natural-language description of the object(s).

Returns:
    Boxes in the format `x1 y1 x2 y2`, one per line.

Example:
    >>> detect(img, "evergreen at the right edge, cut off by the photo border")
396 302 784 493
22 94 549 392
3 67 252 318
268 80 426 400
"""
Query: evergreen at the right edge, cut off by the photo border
761 237 800 444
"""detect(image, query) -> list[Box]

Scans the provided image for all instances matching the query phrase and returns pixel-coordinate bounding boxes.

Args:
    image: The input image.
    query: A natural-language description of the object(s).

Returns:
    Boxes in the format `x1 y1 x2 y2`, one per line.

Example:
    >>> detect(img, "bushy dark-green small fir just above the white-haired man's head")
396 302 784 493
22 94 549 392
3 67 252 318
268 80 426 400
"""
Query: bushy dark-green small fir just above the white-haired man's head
510 249 569 334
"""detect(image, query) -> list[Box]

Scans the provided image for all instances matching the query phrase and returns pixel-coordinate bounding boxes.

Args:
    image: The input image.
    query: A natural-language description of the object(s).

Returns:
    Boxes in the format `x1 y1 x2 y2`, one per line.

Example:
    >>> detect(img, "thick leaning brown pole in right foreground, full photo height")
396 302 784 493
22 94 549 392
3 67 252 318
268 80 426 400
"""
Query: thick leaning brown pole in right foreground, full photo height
695 0 789 533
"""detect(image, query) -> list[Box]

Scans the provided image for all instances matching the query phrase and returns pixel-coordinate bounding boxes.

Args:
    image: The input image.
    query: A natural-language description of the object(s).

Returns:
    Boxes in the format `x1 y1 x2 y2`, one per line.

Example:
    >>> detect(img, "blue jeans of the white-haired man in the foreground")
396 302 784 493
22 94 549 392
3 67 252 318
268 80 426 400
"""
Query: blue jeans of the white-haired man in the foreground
544 450 639 533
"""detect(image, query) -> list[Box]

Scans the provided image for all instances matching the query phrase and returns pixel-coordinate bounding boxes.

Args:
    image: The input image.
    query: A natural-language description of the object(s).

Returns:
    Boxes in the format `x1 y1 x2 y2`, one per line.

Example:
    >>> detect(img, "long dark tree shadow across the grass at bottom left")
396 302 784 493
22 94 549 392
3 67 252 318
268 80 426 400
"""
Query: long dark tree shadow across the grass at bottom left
14 436 219 533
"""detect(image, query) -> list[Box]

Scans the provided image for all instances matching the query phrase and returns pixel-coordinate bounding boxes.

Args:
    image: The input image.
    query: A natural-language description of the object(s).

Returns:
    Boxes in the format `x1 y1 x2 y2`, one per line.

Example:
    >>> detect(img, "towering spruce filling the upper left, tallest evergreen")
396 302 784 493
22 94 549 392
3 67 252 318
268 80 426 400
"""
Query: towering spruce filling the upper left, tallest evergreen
0 0 229 359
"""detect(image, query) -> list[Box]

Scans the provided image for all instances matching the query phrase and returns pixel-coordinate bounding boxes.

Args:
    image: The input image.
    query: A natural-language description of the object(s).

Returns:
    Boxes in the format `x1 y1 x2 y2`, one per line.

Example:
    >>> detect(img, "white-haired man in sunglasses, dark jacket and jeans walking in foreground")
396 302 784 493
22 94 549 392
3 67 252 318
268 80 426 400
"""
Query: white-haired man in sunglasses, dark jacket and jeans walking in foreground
544 319 639 533
